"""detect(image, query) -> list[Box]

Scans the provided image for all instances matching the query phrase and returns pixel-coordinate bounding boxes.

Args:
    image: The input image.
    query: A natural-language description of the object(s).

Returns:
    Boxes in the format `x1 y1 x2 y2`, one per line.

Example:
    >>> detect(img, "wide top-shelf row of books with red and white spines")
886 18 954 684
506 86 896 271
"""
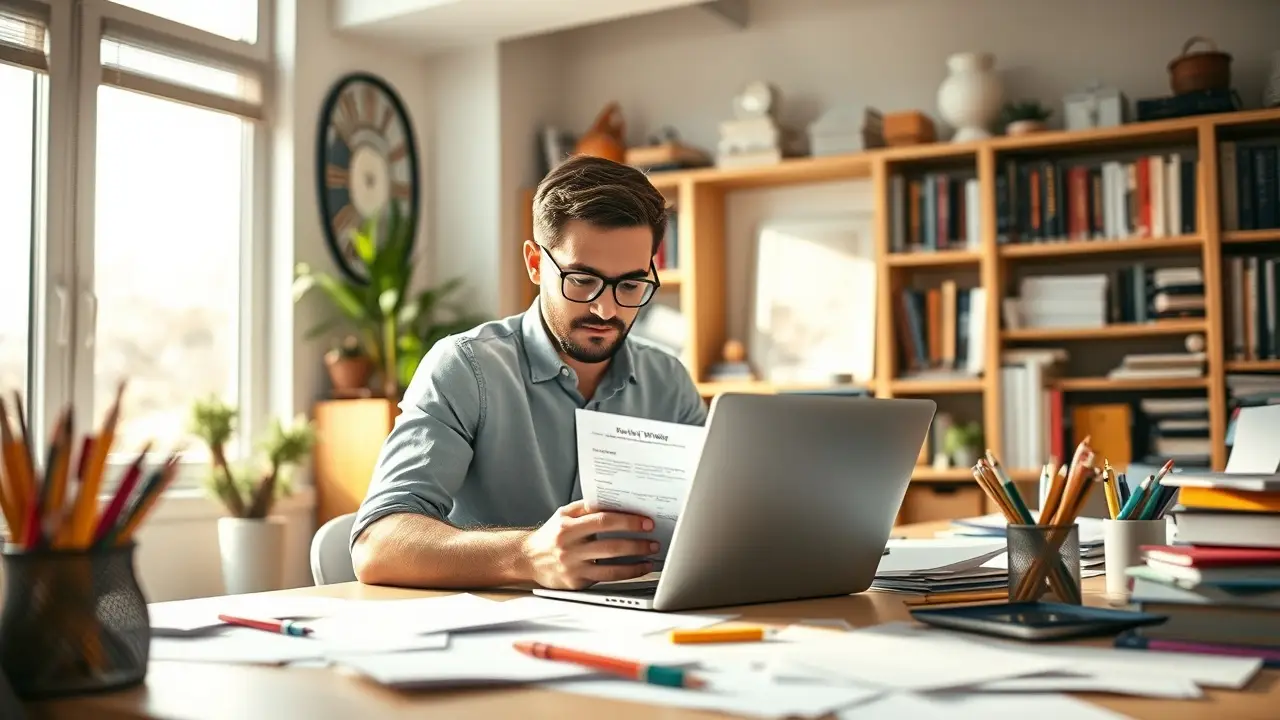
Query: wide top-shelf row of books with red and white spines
996 152 1197 243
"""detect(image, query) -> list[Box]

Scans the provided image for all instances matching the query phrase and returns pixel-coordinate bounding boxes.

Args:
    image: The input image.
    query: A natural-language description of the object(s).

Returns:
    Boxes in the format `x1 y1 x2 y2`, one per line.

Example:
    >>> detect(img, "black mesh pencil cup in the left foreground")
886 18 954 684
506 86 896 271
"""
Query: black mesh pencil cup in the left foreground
0 543 151 700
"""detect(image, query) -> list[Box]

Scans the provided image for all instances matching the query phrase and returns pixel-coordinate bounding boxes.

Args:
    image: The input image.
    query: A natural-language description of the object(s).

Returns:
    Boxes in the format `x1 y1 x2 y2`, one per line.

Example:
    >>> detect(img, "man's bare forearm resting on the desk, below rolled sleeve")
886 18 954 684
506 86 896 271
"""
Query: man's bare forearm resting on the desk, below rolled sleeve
351 512 532 588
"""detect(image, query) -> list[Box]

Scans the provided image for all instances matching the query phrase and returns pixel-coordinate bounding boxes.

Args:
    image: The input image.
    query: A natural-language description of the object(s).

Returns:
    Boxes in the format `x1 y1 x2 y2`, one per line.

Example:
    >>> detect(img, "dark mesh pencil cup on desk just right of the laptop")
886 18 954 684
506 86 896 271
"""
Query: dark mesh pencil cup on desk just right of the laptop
1007 524 1083 605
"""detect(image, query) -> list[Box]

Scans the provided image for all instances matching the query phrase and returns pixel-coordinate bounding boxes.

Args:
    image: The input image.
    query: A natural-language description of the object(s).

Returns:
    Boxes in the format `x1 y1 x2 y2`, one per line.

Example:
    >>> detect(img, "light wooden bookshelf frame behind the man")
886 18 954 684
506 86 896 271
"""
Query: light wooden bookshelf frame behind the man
521 109 1280 483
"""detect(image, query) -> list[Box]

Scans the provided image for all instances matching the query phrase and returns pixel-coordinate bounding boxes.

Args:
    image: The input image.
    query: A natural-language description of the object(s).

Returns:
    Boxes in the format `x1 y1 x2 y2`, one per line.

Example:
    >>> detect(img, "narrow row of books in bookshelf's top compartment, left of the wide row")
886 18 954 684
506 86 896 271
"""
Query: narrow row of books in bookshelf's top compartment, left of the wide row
890 172 982 252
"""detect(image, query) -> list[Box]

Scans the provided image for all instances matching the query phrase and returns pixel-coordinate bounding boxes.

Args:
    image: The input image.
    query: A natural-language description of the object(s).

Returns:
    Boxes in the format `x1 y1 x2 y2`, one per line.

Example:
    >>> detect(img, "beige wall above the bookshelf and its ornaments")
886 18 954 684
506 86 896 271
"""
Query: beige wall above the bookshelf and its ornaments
558 0 1280 149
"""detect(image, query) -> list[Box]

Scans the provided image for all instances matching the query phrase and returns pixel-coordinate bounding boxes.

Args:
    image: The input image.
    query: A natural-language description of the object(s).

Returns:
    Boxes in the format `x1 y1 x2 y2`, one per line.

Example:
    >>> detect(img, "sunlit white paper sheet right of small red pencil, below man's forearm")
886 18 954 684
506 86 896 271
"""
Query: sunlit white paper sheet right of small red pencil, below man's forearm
307 593 552 637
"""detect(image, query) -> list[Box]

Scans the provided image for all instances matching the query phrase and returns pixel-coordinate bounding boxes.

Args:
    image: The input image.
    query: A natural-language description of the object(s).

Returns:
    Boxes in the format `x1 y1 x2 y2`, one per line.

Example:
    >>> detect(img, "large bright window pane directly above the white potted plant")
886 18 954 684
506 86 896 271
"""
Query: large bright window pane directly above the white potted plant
92 86 246 454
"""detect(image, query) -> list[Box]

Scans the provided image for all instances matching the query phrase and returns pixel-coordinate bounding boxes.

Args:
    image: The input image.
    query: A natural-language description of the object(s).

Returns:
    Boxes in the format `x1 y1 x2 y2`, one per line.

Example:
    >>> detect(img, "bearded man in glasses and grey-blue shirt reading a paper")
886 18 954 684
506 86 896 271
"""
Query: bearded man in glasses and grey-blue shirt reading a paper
352 151 707 589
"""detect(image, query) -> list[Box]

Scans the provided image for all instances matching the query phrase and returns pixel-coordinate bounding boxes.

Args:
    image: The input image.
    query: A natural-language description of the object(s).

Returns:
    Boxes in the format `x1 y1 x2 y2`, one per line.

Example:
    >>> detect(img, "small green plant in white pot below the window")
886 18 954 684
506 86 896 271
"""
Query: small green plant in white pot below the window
191 396 315 594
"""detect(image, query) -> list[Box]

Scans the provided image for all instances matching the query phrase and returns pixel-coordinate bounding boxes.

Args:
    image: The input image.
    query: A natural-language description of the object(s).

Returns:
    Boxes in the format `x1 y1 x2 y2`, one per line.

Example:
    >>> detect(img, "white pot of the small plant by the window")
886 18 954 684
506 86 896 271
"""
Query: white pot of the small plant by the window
218 518 284 594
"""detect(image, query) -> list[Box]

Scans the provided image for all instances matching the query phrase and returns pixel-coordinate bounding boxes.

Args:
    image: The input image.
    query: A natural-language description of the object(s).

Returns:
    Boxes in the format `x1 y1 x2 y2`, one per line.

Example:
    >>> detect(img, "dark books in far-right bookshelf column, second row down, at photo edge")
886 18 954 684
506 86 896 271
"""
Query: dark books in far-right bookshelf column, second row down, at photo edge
1222 255 1280 360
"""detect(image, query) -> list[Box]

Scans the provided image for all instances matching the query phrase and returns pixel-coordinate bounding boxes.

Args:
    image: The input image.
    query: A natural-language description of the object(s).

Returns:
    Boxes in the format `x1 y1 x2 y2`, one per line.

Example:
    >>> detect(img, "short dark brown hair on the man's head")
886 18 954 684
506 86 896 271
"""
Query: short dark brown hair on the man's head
534 155 667 254
